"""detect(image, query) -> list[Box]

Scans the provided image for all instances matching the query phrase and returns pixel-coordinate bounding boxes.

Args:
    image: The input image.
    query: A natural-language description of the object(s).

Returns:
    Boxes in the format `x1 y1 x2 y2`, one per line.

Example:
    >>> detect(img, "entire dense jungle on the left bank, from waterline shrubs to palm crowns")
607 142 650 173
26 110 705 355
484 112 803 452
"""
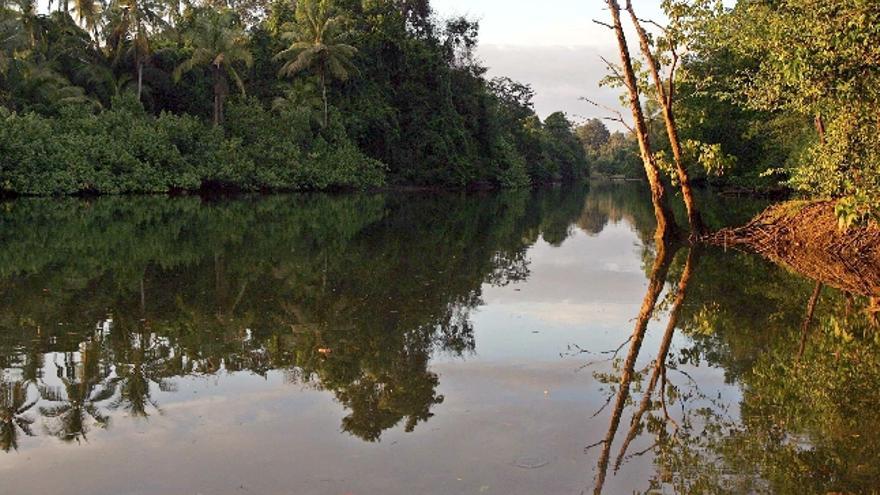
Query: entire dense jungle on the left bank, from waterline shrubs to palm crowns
0 0 588 194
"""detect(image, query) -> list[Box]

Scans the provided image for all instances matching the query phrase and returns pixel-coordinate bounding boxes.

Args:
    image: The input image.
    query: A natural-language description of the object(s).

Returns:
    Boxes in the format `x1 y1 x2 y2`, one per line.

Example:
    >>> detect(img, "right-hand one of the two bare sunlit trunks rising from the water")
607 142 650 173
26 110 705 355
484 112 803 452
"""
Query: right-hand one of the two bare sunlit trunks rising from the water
626 0 705 236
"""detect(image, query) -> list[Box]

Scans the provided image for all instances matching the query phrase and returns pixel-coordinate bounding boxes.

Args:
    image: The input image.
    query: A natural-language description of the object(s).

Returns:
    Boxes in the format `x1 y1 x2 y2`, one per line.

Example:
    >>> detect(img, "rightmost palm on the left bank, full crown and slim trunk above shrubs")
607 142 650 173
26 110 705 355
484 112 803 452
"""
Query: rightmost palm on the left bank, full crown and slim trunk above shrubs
275 0 357 126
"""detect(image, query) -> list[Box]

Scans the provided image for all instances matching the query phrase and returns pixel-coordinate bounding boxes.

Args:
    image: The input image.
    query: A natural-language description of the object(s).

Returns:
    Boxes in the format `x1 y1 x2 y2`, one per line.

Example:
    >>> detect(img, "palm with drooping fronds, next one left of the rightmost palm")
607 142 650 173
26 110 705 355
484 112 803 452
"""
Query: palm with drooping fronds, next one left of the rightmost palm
174 10 254 125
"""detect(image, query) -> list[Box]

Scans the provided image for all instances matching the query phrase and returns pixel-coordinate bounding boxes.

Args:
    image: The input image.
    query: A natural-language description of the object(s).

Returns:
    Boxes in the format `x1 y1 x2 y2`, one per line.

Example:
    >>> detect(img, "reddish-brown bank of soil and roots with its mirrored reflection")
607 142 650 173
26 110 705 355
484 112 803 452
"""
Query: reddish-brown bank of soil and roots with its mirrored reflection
705 201 880 297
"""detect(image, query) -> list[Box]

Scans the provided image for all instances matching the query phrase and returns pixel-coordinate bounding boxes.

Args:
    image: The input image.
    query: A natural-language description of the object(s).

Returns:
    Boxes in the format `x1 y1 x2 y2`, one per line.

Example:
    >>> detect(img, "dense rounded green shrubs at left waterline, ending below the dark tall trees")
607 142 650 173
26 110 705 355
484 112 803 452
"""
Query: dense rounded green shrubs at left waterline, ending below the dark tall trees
0 97 384 195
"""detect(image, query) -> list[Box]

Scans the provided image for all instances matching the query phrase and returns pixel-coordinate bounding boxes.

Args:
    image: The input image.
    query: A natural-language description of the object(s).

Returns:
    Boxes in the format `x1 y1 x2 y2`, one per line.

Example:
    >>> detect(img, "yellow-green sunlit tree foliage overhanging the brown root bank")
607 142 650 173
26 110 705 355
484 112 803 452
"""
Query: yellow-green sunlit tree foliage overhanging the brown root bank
691 0 880 225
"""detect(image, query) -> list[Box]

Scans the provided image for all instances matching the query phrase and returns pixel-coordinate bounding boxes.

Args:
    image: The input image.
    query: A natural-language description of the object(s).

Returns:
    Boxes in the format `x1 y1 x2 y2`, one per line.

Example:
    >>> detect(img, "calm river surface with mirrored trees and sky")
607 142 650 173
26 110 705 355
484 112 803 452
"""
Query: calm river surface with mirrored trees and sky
0 183 880 495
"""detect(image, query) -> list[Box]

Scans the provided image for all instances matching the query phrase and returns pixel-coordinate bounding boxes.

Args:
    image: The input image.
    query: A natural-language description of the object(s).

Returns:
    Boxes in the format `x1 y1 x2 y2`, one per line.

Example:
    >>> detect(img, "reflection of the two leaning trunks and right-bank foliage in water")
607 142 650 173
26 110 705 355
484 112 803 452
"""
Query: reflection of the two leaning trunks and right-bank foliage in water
587 222 880 494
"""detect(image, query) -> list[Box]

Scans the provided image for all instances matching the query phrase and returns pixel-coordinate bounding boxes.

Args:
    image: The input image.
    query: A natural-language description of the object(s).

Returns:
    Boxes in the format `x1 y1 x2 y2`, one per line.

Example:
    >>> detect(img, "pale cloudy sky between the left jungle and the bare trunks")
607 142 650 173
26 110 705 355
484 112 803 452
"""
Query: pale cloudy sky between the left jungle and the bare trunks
431 0 662 128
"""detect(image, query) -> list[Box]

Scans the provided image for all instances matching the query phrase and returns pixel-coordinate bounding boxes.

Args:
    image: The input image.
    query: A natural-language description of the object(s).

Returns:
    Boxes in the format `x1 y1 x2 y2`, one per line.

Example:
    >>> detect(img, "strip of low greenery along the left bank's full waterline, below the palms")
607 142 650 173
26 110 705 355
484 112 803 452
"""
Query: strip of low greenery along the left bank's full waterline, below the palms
0 98 589 196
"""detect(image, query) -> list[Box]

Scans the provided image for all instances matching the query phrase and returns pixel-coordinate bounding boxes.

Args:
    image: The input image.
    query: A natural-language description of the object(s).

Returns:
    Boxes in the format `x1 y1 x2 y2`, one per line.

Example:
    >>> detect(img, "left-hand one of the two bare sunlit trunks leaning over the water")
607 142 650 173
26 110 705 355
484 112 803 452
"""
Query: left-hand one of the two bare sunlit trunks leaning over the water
606 0 675 237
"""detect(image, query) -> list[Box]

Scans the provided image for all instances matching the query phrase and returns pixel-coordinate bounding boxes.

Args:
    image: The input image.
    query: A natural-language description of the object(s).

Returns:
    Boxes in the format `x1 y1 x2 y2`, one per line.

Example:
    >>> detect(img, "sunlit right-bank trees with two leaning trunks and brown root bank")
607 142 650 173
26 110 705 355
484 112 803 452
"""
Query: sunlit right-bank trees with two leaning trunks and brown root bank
594 0 880 268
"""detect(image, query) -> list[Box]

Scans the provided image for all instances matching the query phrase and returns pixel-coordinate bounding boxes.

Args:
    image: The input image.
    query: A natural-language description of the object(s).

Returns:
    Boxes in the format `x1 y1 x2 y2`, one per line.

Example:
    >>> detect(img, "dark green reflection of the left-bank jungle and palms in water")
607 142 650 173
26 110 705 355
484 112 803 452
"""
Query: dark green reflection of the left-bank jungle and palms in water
0 187 586 450
